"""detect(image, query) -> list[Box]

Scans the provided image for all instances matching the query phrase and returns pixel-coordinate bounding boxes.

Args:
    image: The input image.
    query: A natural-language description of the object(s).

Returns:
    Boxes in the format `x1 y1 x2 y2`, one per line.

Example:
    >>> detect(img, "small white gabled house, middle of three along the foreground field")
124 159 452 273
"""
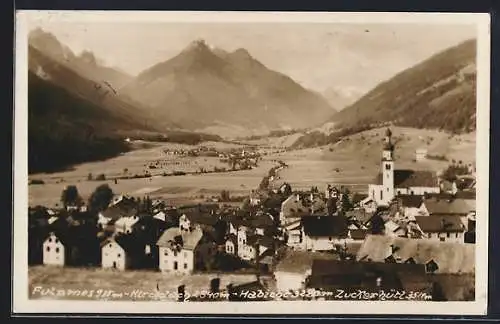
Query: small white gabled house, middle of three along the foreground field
101 233 146 270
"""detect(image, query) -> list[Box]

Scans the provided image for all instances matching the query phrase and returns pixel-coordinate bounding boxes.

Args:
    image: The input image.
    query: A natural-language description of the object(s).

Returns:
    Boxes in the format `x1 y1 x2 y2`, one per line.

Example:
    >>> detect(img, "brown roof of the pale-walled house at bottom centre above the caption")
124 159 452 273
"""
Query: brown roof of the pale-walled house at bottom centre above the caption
275 249 339 274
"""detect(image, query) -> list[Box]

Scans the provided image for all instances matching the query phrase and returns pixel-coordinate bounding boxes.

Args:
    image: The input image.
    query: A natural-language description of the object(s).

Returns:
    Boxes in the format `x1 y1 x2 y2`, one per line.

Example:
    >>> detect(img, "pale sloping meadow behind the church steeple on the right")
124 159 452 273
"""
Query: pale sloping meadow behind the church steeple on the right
268 127 476 192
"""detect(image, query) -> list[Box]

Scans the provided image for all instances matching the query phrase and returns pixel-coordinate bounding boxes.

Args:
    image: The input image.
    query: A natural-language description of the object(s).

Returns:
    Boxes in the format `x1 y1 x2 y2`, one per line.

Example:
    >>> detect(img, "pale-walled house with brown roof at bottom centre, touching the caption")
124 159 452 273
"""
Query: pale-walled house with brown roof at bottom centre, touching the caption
274 249 339 292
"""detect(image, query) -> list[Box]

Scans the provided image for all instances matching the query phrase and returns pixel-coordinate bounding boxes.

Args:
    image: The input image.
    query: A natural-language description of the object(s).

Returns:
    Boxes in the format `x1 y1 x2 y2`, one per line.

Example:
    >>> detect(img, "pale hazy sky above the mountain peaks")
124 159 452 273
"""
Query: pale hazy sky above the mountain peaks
30 21 476 93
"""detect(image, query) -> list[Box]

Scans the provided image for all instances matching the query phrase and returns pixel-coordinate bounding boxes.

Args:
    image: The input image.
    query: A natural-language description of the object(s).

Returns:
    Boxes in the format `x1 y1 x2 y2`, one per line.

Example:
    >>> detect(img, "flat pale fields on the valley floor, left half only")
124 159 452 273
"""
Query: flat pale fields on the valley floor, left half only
29 143 275 206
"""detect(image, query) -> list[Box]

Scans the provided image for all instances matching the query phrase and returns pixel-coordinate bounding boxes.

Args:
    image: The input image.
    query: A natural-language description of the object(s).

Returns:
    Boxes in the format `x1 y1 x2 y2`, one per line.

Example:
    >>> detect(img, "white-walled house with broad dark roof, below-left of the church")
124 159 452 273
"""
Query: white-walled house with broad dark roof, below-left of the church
302 216 349 251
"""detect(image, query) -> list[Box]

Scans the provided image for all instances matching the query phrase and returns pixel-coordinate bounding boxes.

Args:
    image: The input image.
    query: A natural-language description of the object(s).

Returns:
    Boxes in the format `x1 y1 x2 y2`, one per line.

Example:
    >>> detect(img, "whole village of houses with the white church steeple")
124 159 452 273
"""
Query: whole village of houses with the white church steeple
28 129 476 301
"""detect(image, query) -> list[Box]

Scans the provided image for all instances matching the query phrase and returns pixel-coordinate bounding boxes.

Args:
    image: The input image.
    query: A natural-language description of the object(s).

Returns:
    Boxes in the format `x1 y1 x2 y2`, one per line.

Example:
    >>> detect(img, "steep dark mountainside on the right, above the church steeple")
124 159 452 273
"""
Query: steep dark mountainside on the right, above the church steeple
335 40 476 132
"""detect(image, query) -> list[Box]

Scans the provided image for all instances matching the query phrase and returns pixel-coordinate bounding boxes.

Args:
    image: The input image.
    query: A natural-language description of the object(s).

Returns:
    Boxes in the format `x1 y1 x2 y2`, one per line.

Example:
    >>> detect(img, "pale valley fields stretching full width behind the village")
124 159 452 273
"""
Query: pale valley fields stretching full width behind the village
29 127 476 206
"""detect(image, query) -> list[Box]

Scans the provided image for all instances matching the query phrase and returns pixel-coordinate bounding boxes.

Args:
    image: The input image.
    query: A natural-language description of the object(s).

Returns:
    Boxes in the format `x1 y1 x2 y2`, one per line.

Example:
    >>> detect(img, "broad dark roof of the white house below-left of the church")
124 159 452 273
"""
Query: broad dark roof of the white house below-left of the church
302 216 348 237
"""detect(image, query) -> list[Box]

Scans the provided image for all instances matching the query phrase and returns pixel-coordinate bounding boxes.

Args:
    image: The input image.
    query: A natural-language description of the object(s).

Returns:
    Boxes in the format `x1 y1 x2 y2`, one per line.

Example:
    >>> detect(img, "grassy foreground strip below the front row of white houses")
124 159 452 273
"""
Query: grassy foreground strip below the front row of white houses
28 266 264 300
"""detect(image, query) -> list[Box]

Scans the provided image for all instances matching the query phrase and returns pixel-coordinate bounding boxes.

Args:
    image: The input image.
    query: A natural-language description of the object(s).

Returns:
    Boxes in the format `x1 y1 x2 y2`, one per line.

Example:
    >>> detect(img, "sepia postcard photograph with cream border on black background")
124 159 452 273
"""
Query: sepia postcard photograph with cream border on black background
13 11 490 315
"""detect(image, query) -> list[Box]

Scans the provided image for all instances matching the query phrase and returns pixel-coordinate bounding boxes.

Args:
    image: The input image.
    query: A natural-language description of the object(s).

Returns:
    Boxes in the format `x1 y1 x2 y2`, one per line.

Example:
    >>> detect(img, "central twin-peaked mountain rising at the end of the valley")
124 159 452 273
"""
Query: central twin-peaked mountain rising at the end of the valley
125 40 335 135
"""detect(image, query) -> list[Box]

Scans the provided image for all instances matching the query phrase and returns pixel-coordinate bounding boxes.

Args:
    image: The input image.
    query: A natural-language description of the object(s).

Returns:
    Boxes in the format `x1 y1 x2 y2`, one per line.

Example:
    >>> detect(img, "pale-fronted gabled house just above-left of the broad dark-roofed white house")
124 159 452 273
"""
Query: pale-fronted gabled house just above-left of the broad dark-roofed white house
279 193 327 226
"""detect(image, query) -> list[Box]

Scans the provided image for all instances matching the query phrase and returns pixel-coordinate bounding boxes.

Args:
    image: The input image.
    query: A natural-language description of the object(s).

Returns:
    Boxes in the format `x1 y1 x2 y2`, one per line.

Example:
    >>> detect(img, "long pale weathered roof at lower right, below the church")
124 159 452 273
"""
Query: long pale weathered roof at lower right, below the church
356 233 476 273
